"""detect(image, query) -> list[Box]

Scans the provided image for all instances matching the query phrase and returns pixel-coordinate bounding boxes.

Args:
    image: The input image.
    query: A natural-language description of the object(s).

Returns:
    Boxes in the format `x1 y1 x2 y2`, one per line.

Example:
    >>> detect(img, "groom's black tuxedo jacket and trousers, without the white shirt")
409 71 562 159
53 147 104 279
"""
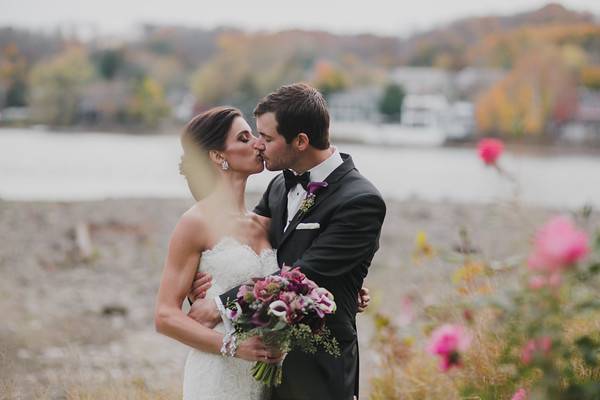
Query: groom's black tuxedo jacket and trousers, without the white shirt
221 154 386 400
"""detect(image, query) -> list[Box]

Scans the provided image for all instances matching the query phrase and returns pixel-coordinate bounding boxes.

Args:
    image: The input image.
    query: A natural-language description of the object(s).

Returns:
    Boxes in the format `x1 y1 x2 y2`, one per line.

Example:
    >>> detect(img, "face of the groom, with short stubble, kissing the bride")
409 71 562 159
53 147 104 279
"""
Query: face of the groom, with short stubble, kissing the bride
256 112 299 171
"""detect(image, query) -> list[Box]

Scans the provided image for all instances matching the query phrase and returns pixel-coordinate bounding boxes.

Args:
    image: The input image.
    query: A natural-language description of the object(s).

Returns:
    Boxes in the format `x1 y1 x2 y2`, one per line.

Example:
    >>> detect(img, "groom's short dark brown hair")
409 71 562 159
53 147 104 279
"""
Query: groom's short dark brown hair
254 83 329 150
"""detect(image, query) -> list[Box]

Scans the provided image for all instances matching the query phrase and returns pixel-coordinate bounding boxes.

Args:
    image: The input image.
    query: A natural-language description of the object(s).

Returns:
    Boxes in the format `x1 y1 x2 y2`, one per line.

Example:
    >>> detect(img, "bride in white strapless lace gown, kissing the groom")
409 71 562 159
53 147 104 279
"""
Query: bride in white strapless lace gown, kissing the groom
155 107 281 400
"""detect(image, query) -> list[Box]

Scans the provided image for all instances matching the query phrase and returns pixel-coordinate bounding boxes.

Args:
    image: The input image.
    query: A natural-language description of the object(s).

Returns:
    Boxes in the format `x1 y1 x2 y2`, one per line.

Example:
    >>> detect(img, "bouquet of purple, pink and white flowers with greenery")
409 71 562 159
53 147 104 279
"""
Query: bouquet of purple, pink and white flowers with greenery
226 266 340 386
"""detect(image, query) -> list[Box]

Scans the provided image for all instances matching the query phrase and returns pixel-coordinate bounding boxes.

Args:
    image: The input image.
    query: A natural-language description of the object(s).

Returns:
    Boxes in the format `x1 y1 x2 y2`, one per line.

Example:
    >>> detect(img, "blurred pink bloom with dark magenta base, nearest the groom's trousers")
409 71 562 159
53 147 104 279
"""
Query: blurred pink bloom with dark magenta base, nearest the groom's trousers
427 324 471 372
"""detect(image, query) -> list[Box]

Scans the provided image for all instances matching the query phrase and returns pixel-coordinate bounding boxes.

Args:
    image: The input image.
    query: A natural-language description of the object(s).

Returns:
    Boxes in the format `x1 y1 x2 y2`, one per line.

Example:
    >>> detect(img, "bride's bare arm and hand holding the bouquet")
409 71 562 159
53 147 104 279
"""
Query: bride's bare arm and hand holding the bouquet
154 214 278 362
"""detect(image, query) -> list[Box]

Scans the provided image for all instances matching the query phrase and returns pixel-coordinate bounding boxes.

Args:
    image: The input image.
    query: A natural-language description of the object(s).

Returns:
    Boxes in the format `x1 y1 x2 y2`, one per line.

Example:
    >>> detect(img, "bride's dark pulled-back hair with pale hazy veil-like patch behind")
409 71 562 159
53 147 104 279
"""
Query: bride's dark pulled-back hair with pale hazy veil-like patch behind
179 106 243 200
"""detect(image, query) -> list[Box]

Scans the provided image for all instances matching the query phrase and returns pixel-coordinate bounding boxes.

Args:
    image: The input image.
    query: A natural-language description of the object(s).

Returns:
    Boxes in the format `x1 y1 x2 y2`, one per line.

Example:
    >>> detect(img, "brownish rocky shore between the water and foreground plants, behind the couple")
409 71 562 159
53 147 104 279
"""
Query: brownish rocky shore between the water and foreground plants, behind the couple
0 196 600 399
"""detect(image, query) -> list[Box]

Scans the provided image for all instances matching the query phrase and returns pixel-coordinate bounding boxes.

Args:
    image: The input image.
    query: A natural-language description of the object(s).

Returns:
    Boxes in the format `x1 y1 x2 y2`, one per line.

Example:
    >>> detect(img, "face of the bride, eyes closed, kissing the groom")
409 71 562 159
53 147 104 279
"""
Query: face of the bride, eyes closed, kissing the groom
223 117 264 174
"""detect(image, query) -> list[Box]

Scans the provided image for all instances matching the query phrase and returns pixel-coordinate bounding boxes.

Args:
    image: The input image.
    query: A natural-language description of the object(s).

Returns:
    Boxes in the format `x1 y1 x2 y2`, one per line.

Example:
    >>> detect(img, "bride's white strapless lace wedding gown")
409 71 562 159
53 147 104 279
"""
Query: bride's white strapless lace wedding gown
183 237 278 400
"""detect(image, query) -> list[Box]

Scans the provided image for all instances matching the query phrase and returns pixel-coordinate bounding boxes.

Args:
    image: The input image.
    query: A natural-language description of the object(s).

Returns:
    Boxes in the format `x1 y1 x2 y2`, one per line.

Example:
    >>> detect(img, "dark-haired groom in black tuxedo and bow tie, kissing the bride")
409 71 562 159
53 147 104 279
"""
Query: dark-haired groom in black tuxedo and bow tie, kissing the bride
194 83 386 400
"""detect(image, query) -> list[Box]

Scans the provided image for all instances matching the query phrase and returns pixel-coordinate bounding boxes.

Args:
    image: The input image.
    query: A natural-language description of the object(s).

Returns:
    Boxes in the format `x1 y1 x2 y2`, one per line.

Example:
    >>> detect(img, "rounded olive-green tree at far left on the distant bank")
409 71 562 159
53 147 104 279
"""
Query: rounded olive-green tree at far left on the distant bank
30 47 94 125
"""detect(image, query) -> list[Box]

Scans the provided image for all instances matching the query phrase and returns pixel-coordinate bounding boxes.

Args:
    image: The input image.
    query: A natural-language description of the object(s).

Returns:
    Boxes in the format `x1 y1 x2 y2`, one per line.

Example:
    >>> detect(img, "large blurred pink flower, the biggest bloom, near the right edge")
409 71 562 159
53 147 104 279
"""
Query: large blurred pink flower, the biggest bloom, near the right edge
528 216 589 272
